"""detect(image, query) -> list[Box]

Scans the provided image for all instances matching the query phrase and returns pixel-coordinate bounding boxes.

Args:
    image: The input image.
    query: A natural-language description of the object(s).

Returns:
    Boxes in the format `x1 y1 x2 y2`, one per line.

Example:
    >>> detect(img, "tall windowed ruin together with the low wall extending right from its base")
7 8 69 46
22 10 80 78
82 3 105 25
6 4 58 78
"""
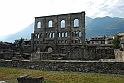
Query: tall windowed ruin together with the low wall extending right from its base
31 12 115 60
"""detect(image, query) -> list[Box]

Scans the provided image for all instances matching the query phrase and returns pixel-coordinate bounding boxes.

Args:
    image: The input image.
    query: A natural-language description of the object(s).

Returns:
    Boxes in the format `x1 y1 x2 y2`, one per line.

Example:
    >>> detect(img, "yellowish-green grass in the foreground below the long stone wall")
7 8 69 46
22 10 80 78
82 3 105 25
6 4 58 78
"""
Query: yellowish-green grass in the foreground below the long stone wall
0 67 124 83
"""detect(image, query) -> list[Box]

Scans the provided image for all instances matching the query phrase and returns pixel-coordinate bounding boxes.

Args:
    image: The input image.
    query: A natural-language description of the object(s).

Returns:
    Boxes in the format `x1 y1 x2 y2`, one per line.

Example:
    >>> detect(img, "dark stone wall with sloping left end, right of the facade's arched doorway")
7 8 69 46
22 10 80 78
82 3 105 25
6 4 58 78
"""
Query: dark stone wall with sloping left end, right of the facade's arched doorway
60 47 115 60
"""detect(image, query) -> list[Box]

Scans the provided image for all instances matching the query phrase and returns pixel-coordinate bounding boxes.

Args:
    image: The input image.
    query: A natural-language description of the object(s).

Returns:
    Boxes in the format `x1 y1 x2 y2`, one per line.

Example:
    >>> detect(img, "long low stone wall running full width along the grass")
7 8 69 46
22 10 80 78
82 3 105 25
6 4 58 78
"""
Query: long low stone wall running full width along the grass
0 60 124 75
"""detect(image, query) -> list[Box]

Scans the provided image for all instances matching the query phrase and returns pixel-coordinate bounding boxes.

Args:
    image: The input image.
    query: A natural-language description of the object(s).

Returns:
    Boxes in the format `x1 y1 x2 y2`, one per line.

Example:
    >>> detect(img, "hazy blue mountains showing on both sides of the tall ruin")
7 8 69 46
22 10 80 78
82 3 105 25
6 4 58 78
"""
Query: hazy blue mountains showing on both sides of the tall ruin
0 16 124 42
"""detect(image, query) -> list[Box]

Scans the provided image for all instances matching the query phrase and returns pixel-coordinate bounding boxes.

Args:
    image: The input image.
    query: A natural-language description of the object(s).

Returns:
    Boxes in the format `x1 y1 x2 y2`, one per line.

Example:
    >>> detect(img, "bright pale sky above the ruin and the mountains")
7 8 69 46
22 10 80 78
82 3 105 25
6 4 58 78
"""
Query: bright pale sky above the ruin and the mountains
0 0 124 37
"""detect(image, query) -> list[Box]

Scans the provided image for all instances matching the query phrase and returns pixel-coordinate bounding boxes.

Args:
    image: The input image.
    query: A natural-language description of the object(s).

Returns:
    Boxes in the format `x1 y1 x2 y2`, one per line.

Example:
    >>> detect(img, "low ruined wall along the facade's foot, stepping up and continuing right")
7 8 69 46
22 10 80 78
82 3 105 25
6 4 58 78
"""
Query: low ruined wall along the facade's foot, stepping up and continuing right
31 48 115 61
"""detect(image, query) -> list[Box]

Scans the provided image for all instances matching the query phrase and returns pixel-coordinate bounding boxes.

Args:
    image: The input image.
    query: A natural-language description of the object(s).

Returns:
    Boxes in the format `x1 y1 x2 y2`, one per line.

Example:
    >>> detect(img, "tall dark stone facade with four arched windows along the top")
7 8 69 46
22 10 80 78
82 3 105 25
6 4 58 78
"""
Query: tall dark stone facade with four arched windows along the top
31 11 85 54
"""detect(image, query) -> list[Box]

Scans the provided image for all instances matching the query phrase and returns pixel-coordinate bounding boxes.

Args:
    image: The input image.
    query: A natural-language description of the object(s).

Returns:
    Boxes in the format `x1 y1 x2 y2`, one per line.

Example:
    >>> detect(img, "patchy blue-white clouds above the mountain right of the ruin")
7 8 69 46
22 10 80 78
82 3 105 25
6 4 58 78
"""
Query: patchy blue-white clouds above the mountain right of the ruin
91 0 124 18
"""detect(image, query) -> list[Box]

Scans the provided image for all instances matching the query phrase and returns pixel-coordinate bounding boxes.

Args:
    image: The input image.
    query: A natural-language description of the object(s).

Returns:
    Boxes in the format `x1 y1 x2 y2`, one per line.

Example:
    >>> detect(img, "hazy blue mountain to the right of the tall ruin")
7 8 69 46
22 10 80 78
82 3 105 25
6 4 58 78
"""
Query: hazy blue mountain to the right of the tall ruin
86 16 124 38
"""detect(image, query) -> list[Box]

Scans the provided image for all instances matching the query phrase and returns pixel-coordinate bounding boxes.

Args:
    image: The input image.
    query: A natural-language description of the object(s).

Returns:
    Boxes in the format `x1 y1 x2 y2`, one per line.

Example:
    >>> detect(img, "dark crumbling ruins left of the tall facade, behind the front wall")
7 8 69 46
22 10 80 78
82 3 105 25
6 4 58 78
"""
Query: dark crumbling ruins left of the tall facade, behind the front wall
0 42 31 60
